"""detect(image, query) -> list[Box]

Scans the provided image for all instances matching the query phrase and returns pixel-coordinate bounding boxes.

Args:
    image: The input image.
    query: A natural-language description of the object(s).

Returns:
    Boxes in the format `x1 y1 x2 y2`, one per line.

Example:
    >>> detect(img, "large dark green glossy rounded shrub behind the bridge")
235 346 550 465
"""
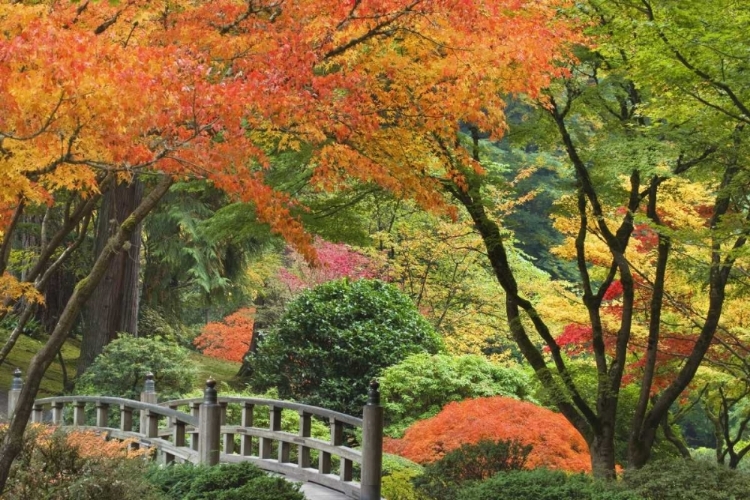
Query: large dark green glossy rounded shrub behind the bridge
249 279 441 414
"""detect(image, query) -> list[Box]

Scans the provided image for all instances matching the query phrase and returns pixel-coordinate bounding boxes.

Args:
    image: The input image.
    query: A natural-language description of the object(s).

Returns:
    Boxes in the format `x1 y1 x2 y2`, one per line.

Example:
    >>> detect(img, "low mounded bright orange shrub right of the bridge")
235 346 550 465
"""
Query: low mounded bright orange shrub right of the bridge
384 396 591 472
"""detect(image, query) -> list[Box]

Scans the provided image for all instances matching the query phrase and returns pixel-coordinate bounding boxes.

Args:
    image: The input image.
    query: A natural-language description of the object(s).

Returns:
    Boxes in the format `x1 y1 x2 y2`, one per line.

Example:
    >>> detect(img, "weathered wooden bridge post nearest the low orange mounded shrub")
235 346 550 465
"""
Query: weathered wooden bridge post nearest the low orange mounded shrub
360 380 383 500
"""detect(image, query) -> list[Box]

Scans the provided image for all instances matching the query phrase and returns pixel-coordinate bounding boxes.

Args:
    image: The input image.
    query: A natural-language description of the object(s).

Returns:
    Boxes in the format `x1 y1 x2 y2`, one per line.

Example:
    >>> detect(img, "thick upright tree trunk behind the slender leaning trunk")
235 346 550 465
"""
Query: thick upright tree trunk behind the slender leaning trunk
78 179 143 375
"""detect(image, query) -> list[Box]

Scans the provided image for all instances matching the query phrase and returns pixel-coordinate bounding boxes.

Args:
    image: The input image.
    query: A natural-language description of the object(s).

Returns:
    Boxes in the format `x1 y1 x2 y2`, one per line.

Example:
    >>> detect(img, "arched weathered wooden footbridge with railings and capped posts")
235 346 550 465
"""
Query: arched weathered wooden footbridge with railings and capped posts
8 370 383 500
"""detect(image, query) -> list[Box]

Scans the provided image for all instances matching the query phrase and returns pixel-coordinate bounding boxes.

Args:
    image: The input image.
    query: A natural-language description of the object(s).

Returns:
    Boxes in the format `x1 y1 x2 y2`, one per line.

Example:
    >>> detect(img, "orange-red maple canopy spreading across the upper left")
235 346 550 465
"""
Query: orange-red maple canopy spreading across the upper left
0 0 576 253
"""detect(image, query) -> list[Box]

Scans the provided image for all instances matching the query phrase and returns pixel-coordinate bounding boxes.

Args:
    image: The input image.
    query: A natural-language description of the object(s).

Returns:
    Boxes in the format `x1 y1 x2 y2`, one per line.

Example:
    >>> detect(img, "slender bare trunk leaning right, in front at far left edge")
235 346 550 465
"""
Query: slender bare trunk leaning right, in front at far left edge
0 177 172 495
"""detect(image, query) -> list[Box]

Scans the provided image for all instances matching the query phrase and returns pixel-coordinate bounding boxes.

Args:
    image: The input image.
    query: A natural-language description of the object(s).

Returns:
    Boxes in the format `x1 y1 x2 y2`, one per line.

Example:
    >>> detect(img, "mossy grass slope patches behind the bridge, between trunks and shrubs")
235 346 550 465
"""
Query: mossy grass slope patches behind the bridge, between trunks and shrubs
0 330 242 397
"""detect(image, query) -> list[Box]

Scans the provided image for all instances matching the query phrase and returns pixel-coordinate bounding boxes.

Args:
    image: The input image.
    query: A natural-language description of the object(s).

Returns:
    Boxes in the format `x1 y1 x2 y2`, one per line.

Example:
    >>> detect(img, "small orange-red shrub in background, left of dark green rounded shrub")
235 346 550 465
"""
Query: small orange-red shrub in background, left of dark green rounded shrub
194 307 255 363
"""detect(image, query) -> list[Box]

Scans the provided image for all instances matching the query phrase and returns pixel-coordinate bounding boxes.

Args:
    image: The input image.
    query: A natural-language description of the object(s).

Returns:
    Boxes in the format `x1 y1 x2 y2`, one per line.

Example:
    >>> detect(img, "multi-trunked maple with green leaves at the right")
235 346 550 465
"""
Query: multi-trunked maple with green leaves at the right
424 1 750 477
